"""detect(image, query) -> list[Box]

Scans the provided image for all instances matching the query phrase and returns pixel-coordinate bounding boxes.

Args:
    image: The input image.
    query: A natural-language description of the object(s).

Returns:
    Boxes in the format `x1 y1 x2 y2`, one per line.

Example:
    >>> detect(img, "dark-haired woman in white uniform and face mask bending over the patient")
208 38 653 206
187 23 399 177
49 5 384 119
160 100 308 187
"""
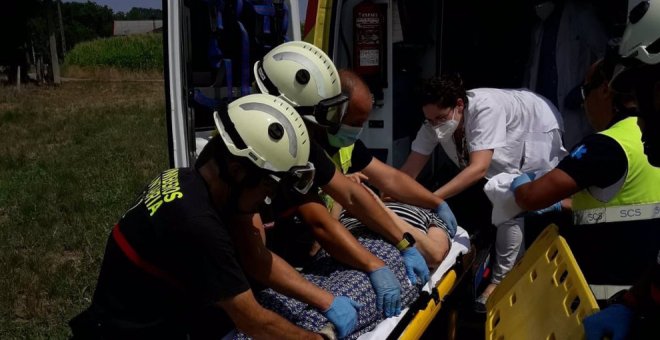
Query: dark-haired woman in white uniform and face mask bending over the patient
401 76 566 308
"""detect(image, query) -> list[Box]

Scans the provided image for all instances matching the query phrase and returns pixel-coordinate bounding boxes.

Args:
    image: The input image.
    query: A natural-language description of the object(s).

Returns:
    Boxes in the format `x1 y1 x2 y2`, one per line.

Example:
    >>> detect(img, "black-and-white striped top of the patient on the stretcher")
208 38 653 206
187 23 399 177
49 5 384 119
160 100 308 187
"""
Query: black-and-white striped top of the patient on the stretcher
339 202 447 233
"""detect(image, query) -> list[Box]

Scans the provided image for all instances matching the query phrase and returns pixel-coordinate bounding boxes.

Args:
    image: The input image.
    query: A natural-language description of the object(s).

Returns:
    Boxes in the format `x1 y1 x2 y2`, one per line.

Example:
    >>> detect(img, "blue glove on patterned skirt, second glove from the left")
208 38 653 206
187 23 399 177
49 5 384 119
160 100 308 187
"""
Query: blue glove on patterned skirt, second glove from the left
369 266 401 318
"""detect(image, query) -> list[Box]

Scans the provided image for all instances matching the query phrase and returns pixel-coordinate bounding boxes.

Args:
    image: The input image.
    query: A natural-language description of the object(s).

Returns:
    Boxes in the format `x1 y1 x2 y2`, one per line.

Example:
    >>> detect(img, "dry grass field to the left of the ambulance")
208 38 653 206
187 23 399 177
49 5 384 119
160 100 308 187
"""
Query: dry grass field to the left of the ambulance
0 81 167 339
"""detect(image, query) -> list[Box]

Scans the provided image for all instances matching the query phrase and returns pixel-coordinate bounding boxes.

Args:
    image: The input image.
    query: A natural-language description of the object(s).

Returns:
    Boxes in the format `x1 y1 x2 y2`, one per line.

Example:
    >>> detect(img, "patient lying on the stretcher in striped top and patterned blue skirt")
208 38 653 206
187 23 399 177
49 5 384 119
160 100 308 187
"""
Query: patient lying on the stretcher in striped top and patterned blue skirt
235 186 451 339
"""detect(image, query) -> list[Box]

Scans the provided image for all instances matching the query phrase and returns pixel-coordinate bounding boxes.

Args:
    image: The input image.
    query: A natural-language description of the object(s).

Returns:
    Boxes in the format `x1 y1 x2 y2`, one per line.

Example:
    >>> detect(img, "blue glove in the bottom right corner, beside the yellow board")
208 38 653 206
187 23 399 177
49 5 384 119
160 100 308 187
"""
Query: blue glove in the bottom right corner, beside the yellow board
583 304 633 340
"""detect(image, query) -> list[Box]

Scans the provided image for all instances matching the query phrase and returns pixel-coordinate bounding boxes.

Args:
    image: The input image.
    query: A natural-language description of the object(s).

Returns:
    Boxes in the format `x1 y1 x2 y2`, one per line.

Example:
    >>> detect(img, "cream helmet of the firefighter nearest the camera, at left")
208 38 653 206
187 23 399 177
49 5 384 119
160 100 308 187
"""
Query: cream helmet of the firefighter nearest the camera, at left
213 94 314 193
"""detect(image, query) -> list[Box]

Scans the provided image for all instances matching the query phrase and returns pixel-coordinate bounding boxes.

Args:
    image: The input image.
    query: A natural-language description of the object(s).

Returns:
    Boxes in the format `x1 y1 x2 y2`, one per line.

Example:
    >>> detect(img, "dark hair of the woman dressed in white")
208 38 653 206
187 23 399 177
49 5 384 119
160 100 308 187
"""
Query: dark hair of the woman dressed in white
418 74 468 107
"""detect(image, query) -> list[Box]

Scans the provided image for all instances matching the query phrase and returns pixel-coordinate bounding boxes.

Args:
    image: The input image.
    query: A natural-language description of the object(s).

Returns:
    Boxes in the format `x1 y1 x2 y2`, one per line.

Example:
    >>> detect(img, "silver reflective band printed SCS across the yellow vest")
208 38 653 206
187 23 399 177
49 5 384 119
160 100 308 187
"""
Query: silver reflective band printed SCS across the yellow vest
573 203 660 225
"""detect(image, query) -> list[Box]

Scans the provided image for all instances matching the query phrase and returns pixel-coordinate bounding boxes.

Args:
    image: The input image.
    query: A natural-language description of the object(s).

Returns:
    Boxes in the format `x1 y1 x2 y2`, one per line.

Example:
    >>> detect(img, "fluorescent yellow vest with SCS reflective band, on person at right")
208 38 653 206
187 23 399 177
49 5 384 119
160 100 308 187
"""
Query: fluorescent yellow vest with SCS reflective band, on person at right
573 117 660 225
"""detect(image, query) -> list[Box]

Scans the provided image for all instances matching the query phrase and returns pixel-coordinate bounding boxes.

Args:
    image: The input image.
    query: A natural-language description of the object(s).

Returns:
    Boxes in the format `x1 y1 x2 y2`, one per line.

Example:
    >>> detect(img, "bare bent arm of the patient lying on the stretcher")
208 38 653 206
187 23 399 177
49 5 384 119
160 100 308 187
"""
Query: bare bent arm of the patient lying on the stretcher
364 186 450 269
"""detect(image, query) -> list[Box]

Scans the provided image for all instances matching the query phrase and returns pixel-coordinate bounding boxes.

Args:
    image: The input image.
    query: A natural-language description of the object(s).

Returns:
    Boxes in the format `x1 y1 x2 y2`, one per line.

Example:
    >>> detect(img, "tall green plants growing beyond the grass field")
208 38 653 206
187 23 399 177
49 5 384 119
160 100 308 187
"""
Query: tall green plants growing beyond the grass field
64 33 163 71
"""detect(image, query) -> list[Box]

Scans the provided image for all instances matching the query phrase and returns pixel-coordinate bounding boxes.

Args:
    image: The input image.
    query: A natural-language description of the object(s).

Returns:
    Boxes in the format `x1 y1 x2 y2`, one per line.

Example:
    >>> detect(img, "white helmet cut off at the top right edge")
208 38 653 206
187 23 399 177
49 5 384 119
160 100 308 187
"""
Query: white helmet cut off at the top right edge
611 1 660 83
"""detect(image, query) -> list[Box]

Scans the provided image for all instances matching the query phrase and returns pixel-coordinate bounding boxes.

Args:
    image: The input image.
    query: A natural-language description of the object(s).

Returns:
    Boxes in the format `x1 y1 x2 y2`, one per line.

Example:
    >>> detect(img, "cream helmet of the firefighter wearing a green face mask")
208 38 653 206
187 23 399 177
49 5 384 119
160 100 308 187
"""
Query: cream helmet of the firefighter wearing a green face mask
254 41 348 133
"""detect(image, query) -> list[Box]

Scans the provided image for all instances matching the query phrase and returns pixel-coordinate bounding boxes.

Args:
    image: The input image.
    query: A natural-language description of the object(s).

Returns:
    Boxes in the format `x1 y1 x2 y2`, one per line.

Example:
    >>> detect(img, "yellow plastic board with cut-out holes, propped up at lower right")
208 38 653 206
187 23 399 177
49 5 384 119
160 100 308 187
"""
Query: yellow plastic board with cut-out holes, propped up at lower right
485 225 598 340
